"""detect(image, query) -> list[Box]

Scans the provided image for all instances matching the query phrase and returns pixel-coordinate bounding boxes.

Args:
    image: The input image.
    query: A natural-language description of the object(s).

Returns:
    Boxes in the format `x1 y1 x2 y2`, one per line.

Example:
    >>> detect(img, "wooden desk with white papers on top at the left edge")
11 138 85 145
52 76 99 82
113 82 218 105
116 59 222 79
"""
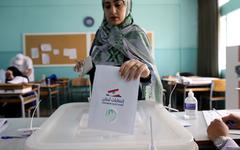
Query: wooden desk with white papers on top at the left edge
0 83 40 118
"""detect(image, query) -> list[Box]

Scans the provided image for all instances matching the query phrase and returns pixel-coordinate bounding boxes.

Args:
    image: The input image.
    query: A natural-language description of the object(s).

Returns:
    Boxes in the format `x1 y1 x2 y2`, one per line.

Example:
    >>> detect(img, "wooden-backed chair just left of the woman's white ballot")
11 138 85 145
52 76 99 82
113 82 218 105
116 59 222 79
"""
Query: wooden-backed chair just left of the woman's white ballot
70 77 91 101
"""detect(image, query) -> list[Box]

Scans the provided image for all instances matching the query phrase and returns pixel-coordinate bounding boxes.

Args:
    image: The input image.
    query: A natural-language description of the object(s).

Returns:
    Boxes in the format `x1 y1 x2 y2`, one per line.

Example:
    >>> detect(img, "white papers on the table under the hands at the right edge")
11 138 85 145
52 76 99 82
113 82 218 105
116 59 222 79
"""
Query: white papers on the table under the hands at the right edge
203 110 240 134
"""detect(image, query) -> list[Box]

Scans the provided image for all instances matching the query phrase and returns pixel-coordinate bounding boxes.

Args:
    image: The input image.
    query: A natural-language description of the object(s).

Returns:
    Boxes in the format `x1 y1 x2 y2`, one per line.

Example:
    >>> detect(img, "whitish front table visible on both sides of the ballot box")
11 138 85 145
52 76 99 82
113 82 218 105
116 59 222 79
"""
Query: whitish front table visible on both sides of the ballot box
0 111 240 150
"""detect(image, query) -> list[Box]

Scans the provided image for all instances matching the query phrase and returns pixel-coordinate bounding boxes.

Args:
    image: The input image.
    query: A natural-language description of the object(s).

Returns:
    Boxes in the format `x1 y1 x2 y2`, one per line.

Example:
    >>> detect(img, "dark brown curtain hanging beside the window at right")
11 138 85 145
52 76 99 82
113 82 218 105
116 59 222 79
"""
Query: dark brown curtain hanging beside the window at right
197 0 219 77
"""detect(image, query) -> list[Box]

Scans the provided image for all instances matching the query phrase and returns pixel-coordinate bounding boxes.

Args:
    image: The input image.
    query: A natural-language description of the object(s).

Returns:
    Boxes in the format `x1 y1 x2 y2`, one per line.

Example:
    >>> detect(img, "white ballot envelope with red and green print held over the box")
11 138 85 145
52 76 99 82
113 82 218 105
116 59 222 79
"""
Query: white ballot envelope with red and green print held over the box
88 65 139 134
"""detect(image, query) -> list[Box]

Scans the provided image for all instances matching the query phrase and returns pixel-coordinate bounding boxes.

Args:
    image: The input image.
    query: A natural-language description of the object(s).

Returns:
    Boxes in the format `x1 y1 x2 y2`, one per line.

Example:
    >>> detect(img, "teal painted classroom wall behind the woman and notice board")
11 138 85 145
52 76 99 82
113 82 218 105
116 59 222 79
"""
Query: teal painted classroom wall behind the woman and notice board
0 0 197 80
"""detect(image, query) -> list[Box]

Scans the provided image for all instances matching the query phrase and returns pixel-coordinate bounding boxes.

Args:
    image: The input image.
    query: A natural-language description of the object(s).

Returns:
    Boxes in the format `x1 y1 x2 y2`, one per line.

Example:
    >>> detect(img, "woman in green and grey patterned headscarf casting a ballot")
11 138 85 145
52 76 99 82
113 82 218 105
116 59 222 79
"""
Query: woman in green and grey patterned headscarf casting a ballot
75 0 162 102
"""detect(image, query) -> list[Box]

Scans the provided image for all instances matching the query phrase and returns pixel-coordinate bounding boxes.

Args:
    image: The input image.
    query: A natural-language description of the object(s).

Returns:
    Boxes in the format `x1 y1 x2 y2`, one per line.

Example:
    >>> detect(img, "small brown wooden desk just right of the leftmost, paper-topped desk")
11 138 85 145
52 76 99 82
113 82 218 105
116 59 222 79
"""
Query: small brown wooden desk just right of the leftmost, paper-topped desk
40 84 60 112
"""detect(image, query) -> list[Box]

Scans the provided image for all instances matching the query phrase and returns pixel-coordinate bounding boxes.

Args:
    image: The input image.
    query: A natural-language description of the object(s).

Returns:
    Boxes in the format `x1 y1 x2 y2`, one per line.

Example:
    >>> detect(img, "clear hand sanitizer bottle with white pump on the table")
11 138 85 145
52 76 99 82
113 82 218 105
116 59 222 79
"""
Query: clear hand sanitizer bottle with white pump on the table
184 90 198 119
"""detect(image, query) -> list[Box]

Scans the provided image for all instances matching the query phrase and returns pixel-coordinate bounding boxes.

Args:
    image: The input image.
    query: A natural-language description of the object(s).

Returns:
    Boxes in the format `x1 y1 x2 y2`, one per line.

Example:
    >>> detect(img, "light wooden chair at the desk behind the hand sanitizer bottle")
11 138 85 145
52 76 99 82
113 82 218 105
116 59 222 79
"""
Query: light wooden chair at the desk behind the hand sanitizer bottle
204 79 226 109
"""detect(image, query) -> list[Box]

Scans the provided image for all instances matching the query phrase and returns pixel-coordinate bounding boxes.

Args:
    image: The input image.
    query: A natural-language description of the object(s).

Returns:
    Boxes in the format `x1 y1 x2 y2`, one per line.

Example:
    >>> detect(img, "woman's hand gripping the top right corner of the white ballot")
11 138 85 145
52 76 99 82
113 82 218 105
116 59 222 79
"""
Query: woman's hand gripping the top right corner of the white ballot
119 59 150 81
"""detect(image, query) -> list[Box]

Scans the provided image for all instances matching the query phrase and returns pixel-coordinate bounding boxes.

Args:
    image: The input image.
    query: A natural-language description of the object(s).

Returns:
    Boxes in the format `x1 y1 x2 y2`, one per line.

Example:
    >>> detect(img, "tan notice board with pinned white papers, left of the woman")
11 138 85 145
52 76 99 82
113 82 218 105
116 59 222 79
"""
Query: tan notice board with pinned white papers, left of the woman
23 33 87 66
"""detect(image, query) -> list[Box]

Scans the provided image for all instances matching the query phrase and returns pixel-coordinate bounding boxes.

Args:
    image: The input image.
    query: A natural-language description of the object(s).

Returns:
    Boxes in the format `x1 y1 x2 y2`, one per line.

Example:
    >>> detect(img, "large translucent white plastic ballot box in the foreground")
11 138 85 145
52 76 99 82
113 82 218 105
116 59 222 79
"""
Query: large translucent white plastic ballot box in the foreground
25 101 198 150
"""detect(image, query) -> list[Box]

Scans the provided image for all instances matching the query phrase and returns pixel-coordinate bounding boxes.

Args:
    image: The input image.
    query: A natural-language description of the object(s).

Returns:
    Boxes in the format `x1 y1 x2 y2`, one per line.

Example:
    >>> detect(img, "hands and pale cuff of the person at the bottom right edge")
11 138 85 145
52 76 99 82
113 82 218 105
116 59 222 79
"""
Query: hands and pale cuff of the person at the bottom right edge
207 114 240 150
